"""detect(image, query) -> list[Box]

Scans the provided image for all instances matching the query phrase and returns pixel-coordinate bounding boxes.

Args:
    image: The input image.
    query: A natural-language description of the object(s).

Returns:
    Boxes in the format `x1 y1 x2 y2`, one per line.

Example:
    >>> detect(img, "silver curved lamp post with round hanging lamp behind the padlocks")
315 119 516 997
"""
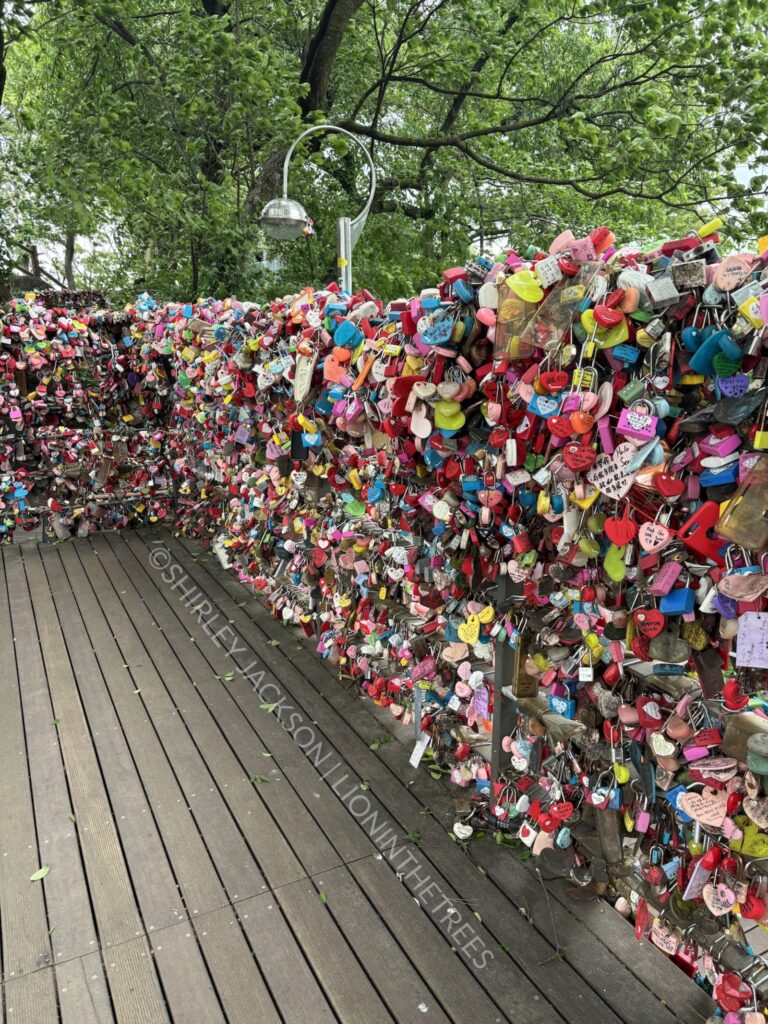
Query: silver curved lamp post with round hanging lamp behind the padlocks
261 125 376 292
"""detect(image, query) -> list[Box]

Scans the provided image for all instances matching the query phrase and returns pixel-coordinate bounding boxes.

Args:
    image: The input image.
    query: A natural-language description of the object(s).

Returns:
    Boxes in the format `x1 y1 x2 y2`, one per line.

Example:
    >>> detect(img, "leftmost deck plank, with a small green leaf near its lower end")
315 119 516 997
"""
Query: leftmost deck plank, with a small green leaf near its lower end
0 552 56 991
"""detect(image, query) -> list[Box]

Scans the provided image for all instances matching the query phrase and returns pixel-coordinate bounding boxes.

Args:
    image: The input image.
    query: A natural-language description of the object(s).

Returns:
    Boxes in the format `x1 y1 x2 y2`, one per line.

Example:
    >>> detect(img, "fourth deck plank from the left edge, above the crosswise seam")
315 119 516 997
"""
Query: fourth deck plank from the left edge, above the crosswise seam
40 547 195 933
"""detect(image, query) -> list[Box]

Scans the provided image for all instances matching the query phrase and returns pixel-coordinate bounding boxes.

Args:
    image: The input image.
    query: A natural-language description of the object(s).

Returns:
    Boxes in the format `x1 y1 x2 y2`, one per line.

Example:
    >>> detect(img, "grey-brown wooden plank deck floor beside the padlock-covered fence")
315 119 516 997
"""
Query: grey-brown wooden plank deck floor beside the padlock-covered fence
0 530 711 1024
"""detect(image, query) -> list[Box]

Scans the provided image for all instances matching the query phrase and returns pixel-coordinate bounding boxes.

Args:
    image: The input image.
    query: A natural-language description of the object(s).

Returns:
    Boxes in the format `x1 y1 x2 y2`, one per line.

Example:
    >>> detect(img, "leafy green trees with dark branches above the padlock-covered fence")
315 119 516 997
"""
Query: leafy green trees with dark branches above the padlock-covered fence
0 0 768 297
